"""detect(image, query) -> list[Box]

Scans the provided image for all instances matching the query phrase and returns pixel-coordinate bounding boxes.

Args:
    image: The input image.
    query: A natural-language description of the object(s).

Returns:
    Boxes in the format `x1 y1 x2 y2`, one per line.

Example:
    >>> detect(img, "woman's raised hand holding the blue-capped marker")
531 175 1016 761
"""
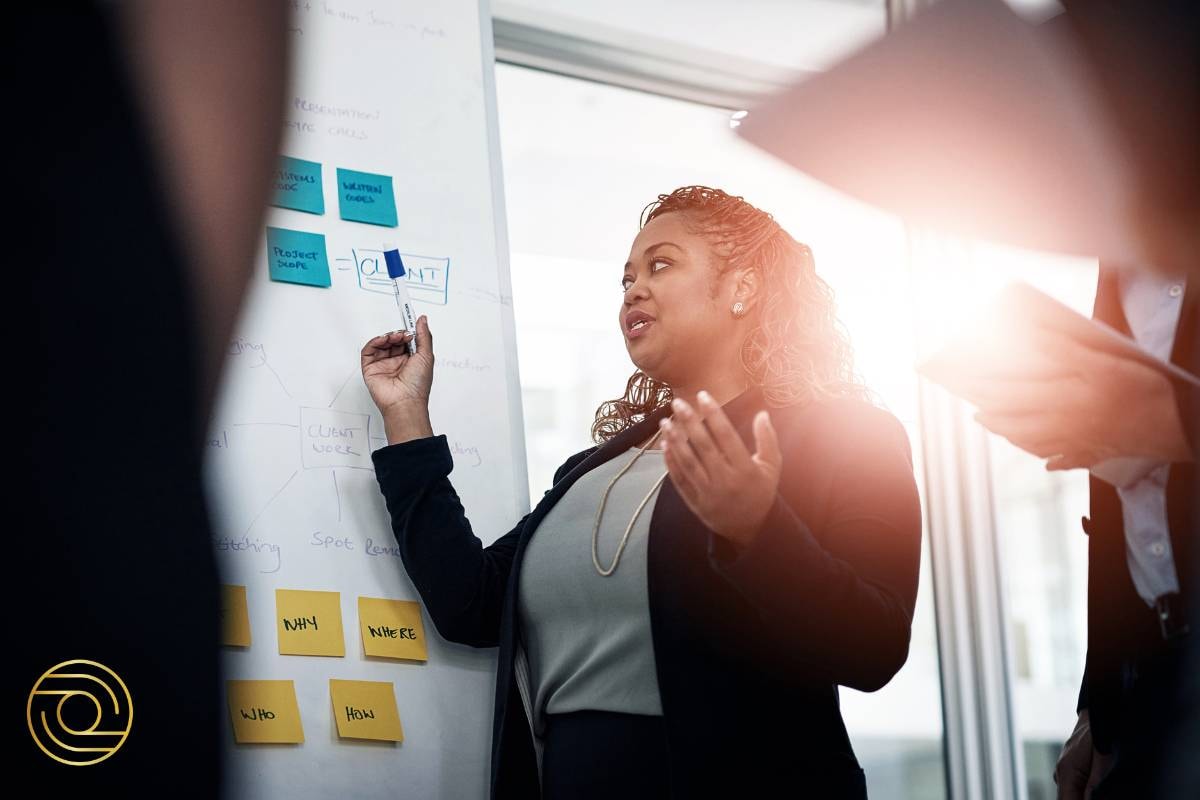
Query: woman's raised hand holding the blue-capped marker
361 314 433 445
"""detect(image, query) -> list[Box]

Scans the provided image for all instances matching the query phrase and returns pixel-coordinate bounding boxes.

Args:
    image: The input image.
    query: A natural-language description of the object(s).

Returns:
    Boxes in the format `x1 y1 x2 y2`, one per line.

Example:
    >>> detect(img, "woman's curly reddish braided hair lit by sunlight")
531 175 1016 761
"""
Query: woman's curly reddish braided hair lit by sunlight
592 186 870 444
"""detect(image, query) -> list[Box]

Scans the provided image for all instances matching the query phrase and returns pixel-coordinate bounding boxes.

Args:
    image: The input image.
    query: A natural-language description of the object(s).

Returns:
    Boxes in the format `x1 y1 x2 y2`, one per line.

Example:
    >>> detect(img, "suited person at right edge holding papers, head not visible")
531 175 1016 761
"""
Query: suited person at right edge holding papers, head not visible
972 266 1200 798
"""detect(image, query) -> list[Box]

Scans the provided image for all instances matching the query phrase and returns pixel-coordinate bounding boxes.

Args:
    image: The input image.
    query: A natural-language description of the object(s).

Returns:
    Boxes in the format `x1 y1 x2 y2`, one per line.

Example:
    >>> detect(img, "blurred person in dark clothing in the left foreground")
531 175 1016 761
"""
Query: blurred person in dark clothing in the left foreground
16 0 287 798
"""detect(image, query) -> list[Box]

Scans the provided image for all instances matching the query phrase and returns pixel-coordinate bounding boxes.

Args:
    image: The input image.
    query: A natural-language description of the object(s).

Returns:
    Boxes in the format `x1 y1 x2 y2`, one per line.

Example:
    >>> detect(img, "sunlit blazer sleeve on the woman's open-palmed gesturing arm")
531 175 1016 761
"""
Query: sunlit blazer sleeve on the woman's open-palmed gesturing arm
709 408 922 691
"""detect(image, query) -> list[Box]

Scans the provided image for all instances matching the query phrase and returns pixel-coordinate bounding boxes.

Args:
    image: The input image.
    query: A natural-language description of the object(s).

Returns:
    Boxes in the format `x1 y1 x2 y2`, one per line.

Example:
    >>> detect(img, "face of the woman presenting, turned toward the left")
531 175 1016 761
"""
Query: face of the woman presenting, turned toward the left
619 212 740 386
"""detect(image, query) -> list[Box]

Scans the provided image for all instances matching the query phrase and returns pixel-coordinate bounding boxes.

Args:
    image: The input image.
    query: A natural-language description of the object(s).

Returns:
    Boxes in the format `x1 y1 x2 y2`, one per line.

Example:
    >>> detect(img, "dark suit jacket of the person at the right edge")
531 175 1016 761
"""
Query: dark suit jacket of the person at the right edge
1080 267 1200 790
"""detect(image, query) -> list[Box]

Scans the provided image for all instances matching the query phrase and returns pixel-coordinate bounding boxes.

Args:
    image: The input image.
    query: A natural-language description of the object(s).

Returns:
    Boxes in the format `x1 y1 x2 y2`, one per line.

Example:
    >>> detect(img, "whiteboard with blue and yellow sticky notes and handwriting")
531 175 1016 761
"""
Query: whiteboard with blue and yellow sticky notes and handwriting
204 0 529 800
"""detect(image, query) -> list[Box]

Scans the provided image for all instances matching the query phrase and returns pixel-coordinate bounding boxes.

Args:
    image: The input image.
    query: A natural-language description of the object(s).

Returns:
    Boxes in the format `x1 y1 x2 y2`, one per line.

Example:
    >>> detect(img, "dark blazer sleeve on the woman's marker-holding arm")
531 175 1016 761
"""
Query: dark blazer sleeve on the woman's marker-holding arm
371 434 589 648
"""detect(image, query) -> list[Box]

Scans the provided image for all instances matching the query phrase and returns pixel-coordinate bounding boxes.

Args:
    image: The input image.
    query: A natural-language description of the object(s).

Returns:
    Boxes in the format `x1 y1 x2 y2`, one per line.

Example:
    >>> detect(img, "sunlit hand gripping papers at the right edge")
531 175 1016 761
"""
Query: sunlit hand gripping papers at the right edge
962 333 1194 469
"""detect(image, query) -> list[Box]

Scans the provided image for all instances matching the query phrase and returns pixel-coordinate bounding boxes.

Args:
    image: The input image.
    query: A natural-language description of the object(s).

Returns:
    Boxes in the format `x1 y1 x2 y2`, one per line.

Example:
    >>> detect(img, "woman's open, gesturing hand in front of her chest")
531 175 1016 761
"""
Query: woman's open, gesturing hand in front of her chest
659 392 784 545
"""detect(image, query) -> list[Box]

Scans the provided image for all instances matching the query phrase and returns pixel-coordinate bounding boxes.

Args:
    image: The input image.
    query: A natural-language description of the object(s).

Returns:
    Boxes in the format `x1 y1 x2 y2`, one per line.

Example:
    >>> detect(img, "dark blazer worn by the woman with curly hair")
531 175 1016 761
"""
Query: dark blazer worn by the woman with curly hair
373 389 920 798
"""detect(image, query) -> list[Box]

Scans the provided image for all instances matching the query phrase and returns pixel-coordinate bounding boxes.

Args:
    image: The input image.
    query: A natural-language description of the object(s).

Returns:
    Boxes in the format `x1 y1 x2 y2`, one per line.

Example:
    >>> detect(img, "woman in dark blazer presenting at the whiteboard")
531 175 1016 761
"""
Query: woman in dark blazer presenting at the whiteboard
362 186 920 800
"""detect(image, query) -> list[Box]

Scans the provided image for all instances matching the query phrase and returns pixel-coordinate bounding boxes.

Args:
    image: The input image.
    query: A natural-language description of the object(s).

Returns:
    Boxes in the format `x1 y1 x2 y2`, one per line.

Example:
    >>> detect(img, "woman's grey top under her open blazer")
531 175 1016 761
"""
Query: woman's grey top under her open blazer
517 449 666 735
